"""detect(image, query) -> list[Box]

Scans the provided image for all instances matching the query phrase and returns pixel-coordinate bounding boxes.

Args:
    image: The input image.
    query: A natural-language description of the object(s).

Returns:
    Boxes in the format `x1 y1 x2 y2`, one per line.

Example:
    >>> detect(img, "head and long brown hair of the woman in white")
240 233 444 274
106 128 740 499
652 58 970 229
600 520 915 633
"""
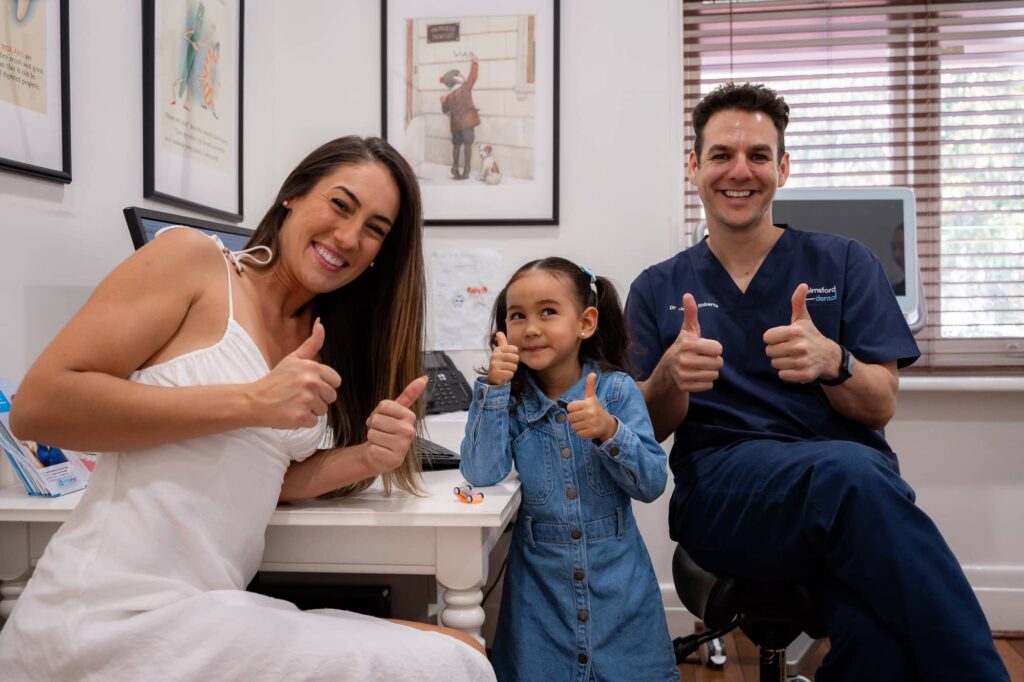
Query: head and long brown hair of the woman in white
249 137 425 495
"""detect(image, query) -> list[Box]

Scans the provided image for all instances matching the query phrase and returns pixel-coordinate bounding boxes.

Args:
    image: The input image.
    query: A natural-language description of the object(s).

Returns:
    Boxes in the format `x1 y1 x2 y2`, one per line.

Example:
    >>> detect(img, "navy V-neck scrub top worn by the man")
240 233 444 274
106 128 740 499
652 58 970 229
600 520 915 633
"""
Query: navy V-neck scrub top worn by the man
626 225 921 460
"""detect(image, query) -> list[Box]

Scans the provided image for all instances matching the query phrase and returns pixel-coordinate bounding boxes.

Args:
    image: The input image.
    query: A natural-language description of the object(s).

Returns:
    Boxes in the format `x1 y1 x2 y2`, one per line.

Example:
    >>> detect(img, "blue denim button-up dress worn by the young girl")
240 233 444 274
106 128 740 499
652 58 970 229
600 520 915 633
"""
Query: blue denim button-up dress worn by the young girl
461 367 679 682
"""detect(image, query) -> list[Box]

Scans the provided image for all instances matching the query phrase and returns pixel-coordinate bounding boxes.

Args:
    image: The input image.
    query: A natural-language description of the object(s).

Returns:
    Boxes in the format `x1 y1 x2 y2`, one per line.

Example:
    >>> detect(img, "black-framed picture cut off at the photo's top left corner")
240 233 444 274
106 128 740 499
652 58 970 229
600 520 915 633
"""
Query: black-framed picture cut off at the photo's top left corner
0 0 71 182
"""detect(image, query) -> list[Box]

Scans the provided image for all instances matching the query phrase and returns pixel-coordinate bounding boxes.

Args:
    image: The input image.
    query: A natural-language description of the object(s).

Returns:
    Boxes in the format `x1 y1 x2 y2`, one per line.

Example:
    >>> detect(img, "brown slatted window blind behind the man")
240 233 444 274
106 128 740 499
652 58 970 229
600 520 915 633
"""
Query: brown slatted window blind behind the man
683 0 1024 371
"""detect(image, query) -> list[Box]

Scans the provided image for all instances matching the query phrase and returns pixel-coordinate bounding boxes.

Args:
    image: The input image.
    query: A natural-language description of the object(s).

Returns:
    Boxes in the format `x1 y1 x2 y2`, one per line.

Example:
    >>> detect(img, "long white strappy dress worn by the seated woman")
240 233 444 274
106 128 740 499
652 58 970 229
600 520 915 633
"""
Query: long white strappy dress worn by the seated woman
0 235 494 682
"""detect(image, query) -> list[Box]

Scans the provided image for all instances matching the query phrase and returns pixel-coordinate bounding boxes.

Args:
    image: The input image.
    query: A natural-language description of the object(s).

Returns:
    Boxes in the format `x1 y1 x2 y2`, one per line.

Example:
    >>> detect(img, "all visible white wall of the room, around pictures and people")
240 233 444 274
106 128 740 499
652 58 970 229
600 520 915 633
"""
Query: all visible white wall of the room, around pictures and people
0 0 1024 632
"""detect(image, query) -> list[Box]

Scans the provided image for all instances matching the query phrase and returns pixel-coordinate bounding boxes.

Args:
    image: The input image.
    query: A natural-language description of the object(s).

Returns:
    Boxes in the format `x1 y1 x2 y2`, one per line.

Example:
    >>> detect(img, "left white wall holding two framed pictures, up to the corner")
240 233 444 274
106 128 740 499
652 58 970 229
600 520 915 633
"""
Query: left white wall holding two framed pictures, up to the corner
0 0 281 401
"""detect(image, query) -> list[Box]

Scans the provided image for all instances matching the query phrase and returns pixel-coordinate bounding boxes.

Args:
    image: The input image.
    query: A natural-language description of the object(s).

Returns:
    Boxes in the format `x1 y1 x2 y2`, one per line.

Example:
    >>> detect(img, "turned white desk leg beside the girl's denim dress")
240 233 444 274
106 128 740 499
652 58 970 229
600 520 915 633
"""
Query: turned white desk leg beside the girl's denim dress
437 527 489 644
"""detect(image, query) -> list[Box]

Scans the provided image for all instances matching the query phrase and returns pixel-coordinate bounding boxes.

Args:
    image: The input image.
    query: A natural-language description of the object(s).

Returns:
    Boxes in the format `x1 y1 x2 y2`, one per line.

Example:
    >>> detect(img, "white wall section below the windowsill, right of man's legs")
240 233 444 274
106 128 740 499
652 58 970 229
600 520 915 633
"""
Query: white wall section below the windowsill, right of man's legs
886 380 1024 631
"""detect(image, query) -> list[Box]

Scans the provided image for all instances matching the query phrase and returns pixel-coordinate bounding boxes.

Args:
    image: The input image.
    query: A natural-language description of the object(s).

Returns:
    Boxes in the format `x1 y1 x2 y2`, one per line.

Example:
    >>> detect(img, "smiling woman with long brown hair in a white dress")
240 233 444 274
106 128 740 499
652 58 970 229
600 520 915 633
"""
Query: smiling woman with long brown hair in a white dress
0 137 494 680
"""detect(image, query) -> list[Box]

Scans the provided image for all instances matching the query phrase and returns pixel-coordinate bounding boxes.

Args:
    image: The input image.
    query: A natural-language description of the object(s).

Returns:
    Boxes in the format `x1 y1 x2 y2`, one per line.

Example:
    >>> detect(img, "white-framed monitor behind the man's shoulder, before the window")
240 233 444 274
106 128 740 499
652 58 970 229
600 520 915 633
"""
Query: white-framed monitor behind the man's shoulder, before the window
695 187 925 332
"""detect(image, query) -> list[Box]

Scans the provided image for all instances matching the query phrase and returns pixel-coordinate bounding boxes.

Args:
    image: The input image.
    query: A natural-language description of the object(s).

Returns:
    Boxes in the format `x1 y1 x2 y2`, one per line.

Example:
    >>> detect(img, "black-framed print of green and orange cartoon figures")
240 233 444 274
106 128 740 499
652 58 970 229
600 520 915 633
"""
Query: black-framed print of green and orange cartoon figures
142 0 244 220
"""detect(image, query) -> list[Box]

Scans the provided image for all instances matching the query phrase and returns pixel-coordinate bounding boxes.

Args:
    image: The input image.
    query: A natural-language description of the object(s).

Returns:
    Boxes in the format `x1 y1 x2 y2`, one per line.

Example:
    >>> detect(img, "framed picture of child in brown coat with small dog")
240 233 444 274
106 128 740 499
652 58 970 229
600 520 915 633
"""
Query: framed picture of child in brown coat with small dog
381 0 559 225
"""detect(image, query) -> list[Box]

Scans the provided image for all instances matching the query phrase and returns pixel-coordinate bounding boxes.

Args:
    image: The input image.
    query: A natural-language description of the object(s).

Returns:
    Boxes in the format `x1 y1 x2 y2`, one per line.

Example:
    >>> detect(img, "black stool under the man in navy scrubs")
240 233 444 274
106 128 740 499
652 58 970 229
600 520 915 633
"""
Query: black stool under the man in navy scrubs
672 546 825 682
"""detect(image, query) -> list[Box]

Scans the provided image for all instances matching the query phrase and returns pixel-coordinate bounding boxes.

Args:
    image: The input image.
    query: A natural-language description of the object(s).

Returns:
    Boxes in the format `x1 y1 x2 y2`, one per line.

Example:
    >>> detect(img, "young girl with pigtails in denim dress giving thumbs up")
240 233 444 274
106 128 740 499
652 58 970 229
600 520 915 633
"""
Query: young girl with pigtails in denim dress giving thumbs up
461 258 679 682
